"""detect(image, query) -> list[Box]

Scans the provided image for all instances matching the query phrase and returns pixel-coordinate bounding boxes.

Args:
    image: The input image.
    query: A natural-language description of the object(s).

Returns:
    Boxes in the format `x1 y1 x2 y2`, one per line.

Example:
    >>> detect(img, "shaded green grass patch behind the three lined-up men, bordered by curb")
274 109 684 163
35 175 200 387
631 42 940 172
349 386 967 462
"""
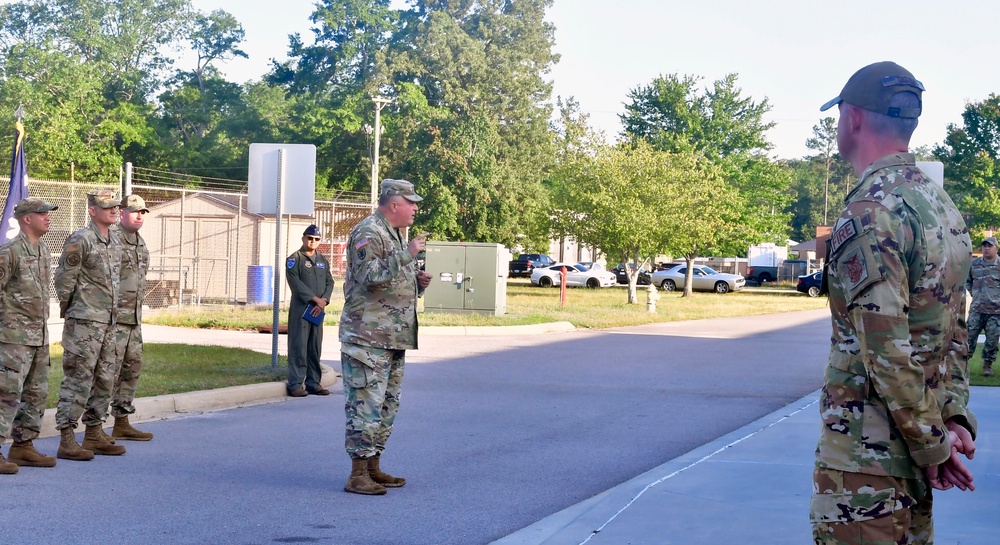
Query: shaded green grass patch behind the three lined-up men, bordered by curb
48 343 288 408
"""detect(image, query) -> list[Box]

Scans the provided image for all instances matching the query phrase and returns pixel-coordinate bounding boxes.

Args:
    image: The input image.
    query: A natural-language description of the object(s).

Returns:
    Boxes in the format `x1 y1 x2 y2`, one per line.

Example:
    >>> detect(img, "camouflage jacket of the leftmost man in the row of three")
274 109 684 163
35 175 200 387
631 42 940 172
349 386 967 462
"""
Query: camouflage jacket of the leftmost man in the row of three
0 233 52 346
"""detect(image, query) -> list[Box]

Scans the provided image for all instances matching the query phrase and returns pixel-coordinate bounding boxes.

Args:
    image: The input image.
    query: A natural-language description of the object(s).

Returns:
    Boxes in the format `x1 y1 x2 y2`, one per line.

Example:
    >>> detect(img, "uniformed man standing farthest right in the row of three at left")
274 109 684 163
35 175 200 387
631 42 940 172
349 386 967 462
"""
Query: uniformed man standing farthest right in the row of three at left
111 195 153 441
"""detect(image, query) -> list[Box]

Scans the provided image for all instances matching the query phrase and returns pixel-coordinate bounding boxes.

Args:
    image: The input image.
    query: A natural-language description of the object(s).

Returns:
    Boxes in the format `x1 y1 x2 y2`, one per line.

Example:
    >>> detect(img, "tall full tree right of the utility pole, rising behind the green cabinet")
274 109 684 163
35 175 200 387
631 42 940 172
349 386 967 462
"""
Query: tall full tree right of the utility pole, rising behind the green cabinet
378 0 556 247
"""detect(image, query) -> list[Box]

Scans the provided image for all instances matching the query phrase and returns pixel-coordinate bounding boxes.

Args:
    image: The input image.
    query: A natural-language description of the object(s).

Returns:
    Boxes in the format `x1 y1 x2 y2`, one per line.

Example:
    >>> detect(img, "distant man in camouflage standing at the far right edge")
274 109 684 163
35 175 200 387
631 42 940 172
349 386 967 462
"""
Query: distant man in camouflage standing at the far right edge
965 237 1000 377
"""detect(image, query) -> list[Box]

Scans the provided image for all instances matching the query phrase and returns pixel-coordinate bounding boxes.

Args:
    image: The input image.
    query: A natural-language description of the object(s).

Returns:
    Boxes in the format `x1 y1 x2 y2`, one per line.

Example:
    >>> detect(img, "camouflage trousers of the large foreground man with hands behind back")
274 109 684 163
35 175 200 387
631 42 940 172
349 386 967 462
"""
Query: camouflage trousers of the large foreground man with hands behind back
809 467 934 545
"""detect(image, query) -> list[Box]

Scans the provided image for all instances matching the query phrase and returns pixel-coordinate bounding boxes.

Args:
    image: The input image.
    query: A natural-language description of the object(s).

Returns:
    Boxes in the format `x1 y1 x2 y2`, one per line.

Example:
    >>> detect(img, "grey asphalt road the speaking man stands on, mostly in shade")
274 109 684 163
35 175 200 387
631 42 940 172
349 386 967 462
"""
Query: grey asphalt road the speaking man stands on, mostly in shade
9 311 829 545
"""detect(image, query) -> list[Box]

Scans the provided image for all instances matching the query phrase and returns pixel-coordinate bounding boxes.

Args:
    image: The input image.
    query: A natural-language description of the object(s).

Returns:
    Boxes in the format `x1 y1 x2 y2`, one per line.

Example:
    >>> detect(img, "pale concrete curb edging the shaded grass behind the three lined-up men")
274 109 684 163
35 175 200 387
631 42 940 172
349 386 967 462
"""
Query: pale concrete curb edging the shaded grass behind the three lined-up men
29 364 340 439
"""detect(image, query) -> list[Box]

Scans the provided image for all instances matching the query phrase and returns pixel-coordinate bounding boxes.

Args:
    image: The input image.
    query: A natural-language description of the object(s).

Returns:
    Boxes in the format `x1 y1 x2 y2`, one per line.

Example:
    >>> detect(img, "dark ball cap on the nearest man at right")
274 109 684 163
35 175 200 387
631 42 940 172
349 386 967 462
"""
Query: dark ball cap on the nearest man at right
819 61 924 119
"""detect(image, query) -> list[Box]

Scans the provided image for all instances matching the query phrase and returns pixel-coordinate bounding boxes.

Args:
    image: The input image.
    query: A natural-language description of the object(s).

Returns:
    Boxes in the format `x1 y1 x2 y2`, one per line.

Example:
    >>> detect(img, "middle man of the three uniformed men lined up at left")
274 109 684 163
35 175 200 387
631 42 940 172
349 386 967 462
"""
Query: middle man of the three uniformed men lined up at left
55 190 125 460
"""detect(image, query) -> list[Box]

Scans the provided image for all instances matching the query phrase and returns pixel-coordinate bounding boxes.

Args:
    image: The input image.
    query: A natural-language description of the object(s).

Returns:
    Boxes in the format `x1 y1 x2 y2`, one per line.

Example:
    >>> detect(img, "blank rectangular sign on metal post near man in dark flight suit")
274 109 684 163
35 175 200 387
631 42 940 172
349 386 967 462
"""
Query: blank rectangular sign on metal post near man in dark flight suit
247 144 316 216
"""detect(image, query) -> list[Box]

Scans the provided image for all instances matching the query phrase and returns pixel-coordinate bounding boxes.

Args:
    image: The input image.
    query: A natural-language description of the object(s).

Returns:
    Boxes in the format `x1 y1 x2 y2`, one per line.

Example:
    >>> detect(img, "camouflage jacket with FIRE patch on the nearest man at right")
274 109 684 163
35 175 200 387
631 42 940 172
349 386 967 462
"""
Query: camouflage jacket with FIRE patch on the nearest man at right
816 154 976 479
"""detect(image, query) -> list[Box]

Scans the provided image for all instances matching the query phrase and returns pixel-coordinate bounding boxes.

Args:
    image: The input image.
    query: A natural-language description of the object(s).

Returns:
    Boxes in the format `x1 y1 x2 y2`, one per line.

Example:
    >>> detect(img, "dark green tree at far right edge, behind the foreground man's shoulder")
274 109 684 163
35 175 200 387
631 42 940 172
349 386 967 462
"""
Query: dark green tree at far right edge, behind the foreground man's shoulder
934 94 1000 232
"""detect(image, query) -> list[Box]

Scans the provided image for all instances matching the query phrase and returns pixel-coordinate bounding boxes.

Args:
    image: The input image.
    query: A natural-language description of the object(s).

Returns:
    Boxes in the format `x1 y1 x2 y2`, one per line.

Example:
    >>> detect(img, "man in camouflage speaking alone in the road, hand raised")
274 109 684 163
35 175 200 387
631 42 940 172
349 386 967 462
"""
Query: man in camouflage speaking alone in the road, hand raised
340 180 431 494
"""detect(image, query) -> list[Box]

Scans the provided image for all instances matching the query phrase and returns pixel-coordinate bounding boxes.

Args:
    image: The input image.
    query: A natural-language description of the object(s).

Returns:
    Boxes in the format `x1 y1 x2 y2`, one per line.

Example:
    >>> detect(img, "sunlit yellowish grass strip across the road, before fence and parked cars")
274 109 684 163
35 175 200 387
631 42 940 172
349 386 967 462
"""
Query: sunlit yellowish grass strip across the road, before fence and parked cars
144 280 827 330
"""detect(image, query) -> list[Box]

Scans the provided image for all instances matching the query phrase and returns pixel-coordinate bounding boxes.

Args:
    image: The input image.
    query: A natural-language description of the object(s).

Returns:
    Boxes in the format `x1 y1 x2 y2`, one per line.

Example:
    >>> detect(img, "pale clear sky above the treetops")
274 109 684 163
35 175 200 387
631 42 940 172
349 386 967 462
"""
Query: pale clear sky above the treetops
193 0 1000 158
